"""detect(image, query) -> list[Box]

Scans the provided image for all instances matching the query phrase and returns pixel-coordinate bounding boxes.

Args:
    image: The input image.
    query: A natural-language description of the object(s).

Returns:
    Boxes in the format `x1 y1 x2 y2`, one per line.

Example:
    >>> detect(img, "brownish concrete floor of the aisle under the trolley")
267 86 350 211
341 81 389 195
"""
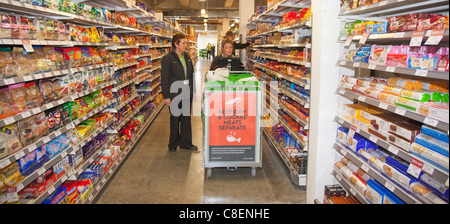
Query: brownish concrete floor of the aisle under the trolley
97 59 306 204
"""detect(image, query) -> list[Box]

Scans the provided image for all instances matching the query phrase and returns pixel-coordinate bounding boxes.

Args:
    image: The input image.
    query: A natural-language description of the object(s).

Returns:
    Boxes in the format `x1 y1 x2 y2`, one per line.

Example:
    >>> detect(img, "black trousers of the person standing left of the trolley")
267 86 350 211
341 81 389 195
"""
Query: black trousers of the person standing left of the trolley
169 97 192 148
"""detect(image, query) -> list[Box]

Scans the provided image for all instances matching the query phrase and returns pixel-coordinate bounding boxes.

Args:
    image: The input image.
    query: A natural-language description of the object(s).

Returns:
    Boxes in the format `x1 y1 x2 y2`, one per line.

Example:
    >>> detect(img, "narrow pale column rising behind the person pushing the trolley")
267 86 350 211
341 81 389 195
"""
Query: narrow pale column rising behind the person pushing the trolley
239 0 255 61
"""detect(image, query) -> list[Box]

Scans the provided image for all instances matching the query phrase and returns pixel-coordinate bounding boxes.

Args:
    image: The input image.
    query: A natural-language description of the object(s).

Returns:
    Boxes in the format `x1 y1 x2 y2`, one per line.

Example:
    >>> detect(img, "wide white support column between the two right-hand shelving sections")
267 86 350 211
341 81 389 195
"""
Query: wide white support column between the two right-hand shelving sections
306 0 341 204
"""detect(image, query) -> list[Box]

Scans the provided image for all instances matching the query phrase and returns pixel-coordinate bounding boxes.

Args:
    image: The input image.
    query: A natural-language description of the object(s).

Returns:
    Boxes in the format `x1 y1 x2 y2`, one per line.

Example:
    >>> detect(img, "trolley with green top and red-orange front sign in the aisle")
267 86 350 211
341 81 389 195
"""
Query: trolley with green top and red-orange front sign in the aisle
202 72 262 177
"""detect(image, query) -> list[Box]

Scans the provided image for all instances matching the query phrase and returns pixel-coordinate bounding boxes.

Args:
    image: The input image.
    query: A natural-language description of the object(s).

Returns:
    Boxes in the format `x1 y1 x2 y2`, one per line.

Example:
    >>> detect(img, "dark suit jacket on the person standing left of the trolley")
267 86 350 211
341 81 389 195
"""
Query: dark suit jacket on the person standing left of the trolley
161 50 195 100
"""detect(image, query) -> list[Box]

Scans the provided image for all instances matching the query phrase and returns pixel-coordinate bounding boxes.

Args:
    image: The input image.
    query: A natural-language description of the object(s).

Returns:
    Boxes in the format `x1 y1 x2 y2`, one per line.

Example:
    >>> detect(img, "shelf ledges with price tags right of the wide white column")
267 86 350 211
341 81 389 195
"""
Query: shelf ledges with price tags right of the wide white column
329 0 449 204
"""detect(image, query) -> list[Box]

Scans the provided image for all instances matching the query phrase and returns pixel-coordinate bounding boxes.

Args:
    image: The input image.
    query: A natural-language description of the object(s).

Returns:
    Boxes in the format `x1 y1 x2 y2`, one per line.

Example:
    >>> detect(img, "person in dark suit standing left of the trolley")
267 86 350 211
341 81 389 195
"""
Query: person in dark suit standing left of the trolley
161 33 198 152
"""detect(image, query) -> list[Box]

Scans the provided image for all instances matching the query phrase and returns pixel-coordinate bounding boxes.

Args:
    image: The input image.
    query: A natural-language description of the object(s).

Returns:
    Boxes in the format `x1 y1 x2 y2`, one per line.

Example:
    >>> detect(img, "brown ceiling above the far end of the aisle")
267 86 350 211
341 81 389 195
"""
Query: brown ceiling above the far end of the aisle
137 0 267 32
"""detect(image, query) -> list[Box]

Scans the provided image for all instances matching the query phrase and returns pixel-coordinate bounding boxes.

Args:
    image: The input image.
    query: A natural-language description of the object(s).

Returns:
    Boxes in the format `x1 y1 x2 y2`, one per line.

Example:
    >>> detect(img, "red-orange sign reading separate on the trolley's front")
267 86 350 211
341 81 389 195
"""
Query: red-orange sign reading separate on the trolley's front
208 92 257 161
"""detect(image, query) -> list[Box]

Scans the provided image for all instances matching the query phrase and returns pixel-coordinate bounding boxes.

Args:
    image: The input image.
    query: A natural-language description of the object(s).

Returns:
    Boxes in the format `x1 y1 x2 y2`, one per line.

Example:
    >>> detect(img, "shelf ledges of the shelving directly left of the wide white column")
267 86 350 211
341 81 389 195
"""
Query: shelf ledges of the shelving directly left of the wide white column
247 0 311 187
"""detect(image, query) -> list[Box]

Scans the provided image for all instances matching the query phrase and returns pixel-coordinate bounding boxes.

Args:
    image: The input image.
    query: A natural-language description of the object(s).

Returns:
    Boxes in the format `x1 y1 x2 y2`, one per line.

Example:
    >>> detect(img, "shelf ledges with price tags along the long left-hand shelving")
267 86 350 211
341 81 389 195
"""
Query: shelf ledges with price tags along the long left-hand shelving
0 0 184 204
